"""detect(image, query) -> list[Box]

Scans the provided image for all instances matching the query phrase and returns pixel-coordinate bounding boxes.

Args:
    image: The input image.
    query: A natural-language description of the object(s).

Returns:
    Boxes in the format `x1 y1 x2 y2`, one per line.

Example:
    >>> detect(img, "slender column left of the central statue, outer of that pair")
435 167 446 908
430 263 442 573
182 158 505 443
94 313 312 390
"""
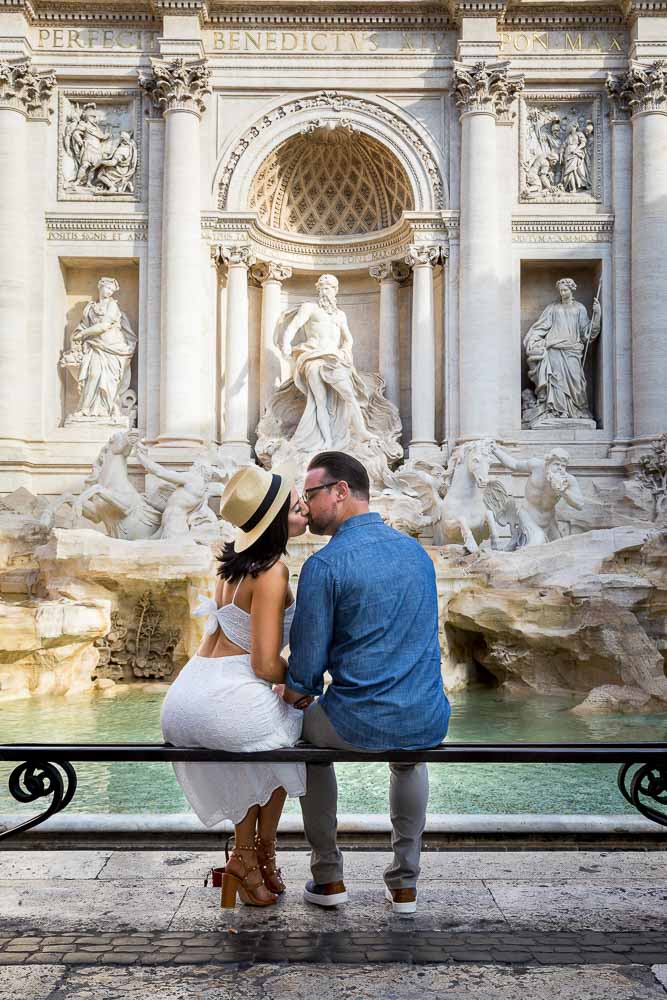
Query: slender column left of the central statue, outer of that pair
218 246 255 462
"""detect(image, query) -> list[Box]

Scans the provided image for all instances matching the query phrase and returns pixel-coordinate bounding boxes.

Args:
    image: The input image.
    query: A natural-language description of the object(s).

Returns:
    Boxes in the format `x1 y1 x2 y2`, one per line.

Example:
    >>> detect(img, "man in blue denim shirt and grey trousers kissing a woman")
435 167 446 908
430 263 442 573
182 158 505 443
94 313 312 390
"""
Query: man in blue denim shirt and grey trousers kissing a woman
285 451 450 913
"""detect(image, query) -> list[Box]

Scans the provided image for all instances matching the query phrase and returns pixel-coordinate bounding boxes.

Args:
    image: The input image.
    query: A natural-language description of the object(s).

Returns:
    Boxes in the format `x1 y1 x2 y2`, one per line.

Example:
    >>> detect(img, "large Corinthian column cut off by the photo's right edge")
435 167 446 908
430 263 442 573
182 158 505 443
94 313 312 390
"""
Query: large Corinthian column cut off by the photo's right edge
607 62 667 439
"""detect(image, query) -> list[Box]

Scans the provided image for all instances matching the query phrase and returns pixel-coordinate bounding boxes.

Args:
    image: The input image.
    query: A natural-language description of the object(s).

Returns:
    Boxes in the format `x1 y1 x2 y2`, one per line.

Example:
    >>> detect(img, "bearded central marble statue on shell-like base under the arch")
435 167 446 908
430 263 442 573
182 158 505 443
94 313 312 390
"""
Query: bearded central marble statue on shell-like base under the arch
255 274 403 488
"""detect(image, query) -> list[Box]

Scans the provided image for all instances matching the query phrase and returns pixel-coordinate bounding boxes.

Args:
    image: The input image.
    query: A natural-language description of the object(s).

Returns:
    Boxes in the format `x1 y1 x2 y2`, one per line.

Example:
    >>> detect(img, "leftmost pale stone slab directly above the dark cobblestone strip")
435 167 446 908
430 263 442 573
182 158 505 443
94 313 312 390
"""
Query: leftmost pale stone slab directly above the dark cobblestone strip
0 880 187 935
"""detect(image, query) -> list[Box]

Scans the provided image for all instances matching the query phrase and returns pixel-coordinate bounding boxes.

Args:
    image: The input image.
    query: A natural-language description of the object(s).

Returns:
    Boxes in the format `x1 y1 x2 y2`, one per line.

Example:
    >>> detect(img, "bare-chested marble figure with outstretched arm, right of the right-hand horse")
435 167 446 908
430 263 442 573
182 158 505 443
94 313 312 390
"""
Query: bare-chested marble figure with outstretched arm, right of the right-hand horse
491 442 585 545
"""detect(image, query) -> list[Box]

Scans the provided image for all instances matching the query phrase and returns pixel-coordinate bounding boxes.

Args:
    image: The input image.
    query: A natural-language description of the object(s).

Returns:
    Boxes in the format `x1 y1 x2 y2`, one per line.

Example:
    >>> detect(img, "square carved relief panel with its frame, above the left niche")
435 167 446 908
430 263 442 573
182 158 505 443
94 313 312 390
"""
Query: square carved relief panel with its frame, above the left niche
58 90 141 201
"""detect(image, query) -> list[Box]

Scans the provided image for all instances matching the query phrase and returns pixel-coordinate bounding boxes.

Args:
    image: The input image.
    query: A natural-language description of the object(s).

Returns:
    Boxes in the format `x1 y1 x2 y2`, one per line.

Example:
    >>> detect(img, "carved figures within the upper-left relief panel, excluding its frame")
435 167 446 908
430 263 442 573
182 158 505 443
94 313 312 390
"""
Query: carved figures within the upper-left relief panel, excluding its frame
62 101 139 195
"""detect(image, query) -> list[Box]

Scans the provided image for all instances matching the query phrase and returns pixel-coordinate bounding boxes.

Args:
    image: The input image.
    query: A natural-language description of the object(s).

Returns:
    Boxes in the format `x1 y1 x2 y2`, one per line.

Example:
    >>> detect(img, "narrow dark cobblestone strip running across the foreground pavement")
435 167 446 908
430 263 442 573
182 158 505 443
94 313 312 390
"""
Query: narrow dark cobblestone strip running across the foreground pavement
0 920 667 966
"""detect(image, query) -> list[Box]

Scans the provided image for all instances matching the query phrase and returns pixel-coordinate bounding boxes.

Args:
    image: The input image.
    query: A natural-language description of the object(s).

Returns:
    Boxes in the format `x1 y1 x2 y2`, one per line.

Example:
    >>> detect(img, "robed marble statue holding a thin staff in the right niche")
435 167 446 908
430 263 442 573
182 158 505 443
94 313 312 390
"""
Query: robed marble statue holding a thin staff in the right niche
522 278 601 427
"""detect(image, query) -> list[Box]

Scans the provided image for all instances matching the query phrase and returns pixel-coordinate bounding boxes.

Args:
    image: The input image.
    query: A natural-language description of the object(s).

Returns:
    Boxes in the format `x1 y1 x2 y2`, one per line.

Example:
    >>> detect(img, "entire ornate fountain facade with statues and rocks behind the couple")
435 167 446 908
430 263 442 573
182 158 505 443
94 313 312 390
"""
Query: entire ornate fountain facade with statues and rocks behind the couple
0 0 667 728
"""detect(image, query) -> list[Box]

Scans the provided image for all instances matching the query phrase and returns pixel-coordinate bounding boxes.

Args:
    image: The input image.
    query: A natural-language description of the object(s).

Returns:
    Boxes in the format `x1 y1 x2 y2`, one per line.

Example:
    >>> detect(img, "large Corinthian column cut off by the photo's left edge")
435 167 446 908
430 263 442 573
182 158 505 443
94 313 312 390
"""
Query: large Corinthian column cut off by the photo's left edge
0 60 56 438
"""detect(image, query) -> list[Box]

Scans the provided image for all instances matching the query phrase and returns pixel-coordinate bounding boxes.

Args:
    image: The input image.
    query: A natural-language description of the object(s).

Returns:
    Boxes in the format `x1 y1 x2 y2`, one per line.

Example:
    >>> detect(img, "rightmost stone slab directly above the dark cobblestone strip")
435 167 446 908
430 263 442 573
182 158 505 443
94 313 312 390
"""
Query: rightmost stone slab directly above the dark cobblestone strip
486 880 667 932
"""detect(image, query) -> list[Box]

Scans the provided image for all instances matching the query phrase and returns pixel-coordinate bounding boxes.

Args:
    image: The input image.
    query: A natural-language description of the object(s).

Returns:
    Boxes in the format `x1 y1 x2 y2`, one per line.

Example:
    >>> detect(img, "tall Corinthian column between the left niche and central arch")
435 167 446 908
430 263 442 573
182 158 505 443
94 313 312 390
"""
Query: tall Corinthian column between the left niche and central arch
139 58 211 444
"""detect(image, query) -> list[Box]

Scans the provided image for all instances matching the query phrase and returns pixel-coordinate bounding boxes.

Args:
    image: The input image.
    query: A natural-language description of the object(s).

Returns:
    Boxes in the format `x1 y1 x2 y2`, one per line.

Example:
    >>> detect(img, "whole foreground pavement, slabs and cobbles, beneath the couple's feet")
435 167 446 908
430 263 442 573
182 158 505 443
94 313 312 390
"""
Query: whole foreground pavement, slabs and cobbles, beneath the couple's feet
0 851 667 1000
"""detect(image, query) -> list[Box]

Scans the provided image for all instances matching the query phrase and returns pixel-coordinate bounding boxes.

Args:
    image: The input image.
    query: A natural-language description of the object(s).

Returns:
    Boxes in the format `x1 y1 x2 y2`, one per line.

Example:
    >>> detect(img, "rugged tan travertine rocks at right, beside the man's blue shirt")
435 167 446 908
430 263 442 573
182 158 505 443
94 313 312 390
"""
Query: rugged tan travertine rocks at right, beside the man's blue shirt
436 528 667 712
